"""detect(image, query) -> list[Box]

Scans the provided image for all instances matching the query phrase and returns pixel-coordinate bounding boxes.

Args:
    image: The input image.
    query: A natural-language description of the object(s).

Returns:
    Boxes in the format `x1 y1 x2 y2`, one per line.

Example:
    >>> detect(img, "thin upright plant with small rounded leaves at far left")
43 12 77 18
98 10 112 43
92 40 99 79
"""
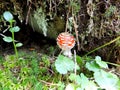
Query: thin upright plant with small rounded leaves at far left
3 11 22 58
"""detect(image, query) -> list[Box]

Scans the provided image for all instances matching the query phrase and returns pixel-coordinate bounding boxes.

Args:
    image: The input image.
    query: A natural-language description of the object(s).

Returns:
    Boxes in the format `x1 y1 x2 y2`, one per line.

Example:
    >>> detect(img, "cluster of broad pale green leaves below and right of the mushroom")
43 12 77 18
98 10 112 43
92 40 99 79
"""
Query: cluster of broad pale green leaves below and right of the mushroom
55 55 120 90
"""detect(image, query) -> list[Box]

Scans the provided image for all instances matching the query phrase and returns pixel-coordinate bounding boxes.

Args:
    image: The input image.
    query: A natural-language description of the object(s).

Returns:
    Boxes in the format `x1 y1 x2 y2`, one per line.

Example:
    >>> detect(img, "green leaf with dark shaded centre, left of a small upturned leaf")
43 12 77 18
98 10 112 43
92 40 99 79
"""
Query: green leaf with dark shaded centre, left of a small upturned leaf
85 61 101 72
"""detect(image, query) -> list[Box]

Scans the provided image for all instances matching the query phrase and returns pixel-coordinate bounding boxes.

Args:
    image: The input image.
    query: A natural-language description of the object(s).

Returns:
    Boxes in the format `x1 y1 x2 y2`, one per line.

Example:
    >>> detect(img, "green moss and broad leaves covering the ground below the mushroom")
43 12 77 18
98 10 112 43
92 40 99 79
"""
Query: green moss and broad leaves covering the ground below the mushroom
0 51 120 90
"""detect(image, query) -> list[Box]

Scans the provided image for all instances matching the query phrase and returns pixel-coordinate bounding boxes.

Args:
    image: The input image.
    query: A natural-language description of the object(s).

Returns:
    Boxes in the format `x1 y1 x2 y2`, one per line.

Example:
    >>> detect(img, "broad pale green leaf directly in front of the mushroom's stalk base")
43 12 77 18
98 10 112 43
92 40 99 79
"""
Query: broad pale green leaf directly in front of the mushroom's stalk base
55 55 75 74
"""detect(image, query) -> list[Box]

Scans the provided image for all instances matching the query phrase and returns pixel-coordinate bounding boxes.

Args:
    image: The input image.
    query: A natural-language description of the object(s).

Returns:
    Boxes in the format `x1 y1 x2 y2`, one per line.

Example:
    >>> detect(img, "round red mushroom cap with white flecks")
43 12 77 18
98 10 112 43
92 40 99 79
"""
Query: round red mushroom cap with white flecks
57 32 75 50
